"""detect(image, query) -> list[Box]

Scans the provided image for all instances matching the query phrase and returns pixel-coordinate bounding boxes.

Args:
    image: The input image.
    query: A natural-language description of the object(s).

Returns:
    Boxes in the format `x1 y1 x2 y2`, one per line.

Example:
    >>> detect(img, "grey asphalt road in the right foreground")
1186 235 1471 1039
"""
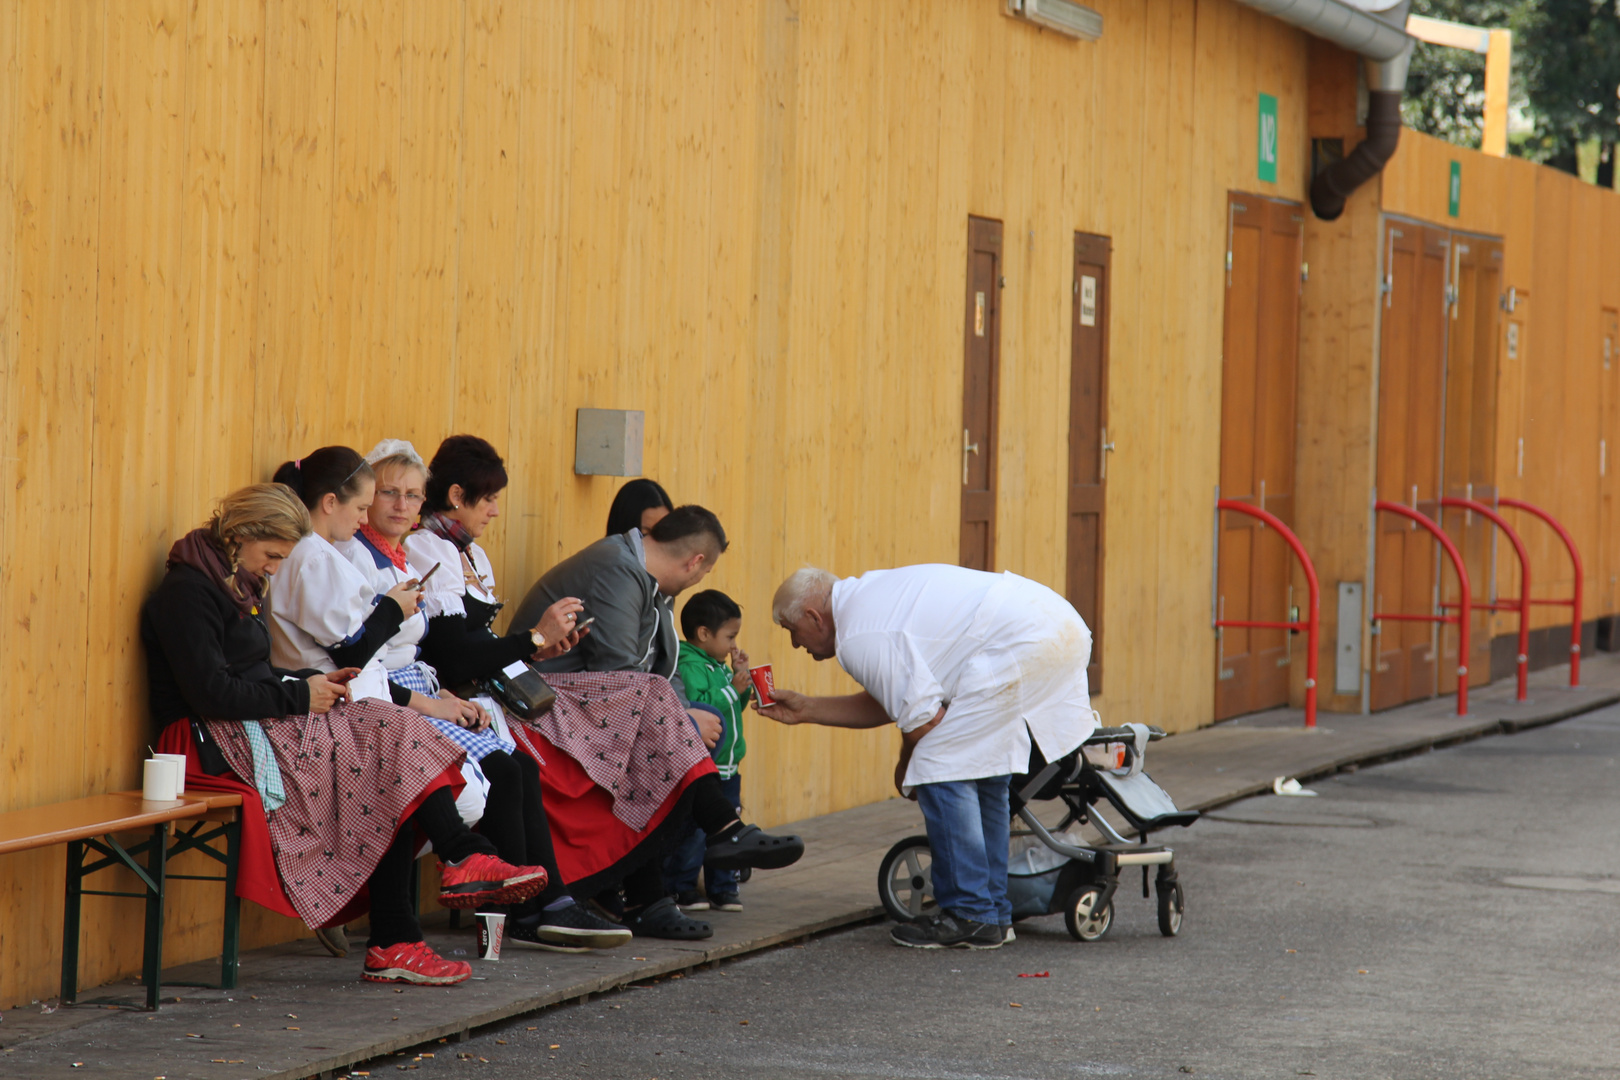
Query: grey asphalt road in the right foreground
371 709 1620 1080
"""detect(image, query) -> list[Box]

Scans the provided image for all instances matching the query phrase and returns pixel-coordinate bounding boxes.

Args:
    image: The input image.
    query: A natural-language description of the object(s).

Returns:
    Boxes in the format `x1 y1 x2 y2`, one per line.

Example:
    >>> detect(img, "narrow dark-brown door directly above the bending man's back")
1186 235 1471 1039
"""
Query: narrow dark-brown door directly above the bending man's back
962 217 1001 570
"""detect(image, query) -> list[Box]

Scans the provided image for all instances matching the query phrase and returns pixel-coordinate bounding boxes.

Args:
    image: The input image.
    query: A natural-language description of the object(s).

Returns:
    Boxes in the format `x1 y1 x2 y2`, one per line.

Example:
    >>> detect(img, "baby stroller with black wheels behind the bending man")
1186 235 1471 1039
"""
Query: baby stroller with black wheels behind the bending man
878 724 1199 941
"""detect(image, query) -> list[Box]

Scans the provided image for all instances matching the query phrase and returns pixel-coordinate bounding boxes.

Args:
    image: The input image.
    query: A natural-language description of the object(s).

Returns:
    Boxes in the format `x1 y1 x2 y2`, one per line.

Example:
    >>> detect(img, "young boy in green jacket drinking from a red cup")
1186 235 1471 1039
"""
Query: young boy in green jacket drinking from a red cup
664 589 753 912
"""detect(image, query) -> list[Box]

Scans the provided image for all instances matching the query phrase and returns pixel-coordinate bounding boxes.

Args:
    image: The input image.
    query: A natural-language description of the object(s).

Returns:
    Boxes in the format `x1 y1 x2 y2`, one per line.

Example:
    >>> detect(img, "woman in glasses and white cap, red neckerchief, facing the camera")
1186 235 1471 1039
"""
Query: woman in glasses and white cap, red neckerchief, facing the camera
339 439 630 952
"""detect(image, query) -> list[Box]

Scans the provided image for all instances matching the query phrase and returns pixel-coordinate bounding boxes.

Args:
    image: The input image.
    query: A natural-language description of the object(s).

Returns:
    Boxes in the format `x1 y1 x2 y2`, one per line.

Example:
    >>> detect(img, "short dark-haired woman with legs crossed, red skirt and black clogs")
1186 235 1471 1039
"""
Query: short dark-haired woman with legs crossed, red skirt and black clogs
405 436 804 941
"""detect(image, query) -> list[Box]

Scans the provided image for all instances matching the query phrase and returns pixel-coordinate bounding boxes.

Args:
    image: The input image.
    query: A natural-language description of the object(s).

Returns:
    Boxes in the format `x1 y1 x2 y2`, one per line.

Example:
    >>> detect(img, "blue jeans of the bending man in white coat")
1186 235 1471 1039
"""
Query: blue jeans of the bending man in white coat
915 776 1013 926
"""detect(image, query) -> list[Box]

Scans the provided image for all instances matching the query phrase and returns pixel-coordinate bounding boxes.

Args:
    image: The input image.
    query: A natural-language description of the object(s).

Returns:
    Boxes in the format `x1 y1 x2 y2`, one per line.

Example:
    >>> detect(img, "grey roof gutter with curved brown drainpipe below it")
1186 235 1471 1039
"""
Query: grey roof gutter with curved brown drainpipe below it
1239 0 1413 222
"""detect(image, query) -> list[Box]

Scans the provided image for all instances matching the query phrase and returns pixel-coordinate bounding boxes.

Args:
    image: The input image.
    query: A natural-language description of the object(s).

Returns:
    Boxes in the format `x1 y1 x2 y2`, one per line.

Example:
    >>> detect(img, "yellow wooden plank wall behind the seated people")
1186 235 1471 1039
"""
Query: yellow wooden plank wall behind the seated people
0 0 1306 1004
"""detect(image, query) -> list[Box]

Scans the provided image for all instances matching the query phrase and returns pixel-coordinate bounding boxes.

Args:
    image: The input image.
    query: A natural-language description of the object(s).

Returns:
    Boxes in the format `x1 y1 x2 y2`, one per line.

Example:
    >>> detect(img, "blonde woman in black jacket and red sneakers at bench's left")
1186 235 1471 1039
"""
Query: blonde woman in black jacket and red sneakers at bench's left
141 484 546 986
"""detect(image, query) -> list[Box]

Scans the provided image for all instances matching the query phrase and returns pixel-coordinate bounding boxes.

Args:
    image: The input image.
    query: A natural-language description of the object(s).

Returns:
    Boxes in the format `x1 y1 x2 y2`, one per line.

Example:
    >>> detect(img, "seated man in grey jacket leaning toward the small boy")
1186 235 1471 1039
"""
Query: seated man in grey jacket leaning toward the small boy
507 505 729 746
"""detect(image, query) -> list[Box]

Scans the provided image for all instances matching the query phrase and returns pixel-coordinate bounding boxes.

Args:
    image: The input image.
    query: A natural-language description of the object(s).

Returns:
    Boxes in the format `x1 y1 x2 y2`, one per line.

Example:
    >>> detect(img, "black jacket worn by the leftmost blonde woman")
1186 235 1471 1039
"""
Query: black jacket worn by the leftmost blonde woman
141 567 316 729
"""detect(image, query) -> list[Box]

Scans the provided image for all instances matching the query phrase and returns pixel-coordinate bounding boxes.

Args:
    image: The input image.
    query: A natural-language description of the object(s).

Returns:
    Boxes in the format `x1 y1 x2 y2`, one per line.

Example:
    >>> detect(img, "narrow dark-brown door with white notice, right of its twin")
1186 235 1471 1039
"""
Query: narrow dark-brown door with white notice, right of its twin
1068 233 1113 693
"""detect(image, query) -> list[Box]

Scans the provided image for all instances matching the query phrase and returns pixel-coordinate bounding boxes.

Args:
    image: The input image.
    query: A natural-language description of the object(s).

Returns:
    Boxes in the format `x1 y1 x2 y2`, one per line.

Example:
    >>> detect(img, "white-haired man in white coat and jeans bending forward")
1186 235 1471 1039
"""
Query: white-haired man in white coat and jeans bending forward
760 565 1097 949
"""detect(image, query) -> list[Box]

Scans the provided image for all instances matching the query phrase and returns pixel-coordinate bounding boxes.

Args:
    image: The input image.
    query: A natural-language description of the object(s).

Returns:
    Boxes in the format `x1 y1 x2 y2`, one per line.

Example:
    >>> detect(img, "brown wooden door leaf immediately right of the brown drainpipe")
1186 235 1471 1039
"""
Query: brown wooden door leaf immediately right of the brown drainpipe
1372 220 1450 709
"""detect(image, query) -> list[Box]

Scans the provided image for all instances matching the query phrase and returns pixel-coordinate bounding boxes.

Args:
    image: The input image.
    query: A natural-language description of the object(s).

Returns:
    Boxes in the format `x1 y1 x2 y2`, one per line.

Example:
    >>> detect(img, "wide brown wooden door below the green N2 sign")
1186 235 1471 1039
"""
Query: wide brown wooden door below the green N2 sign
1215 194 1304 719
